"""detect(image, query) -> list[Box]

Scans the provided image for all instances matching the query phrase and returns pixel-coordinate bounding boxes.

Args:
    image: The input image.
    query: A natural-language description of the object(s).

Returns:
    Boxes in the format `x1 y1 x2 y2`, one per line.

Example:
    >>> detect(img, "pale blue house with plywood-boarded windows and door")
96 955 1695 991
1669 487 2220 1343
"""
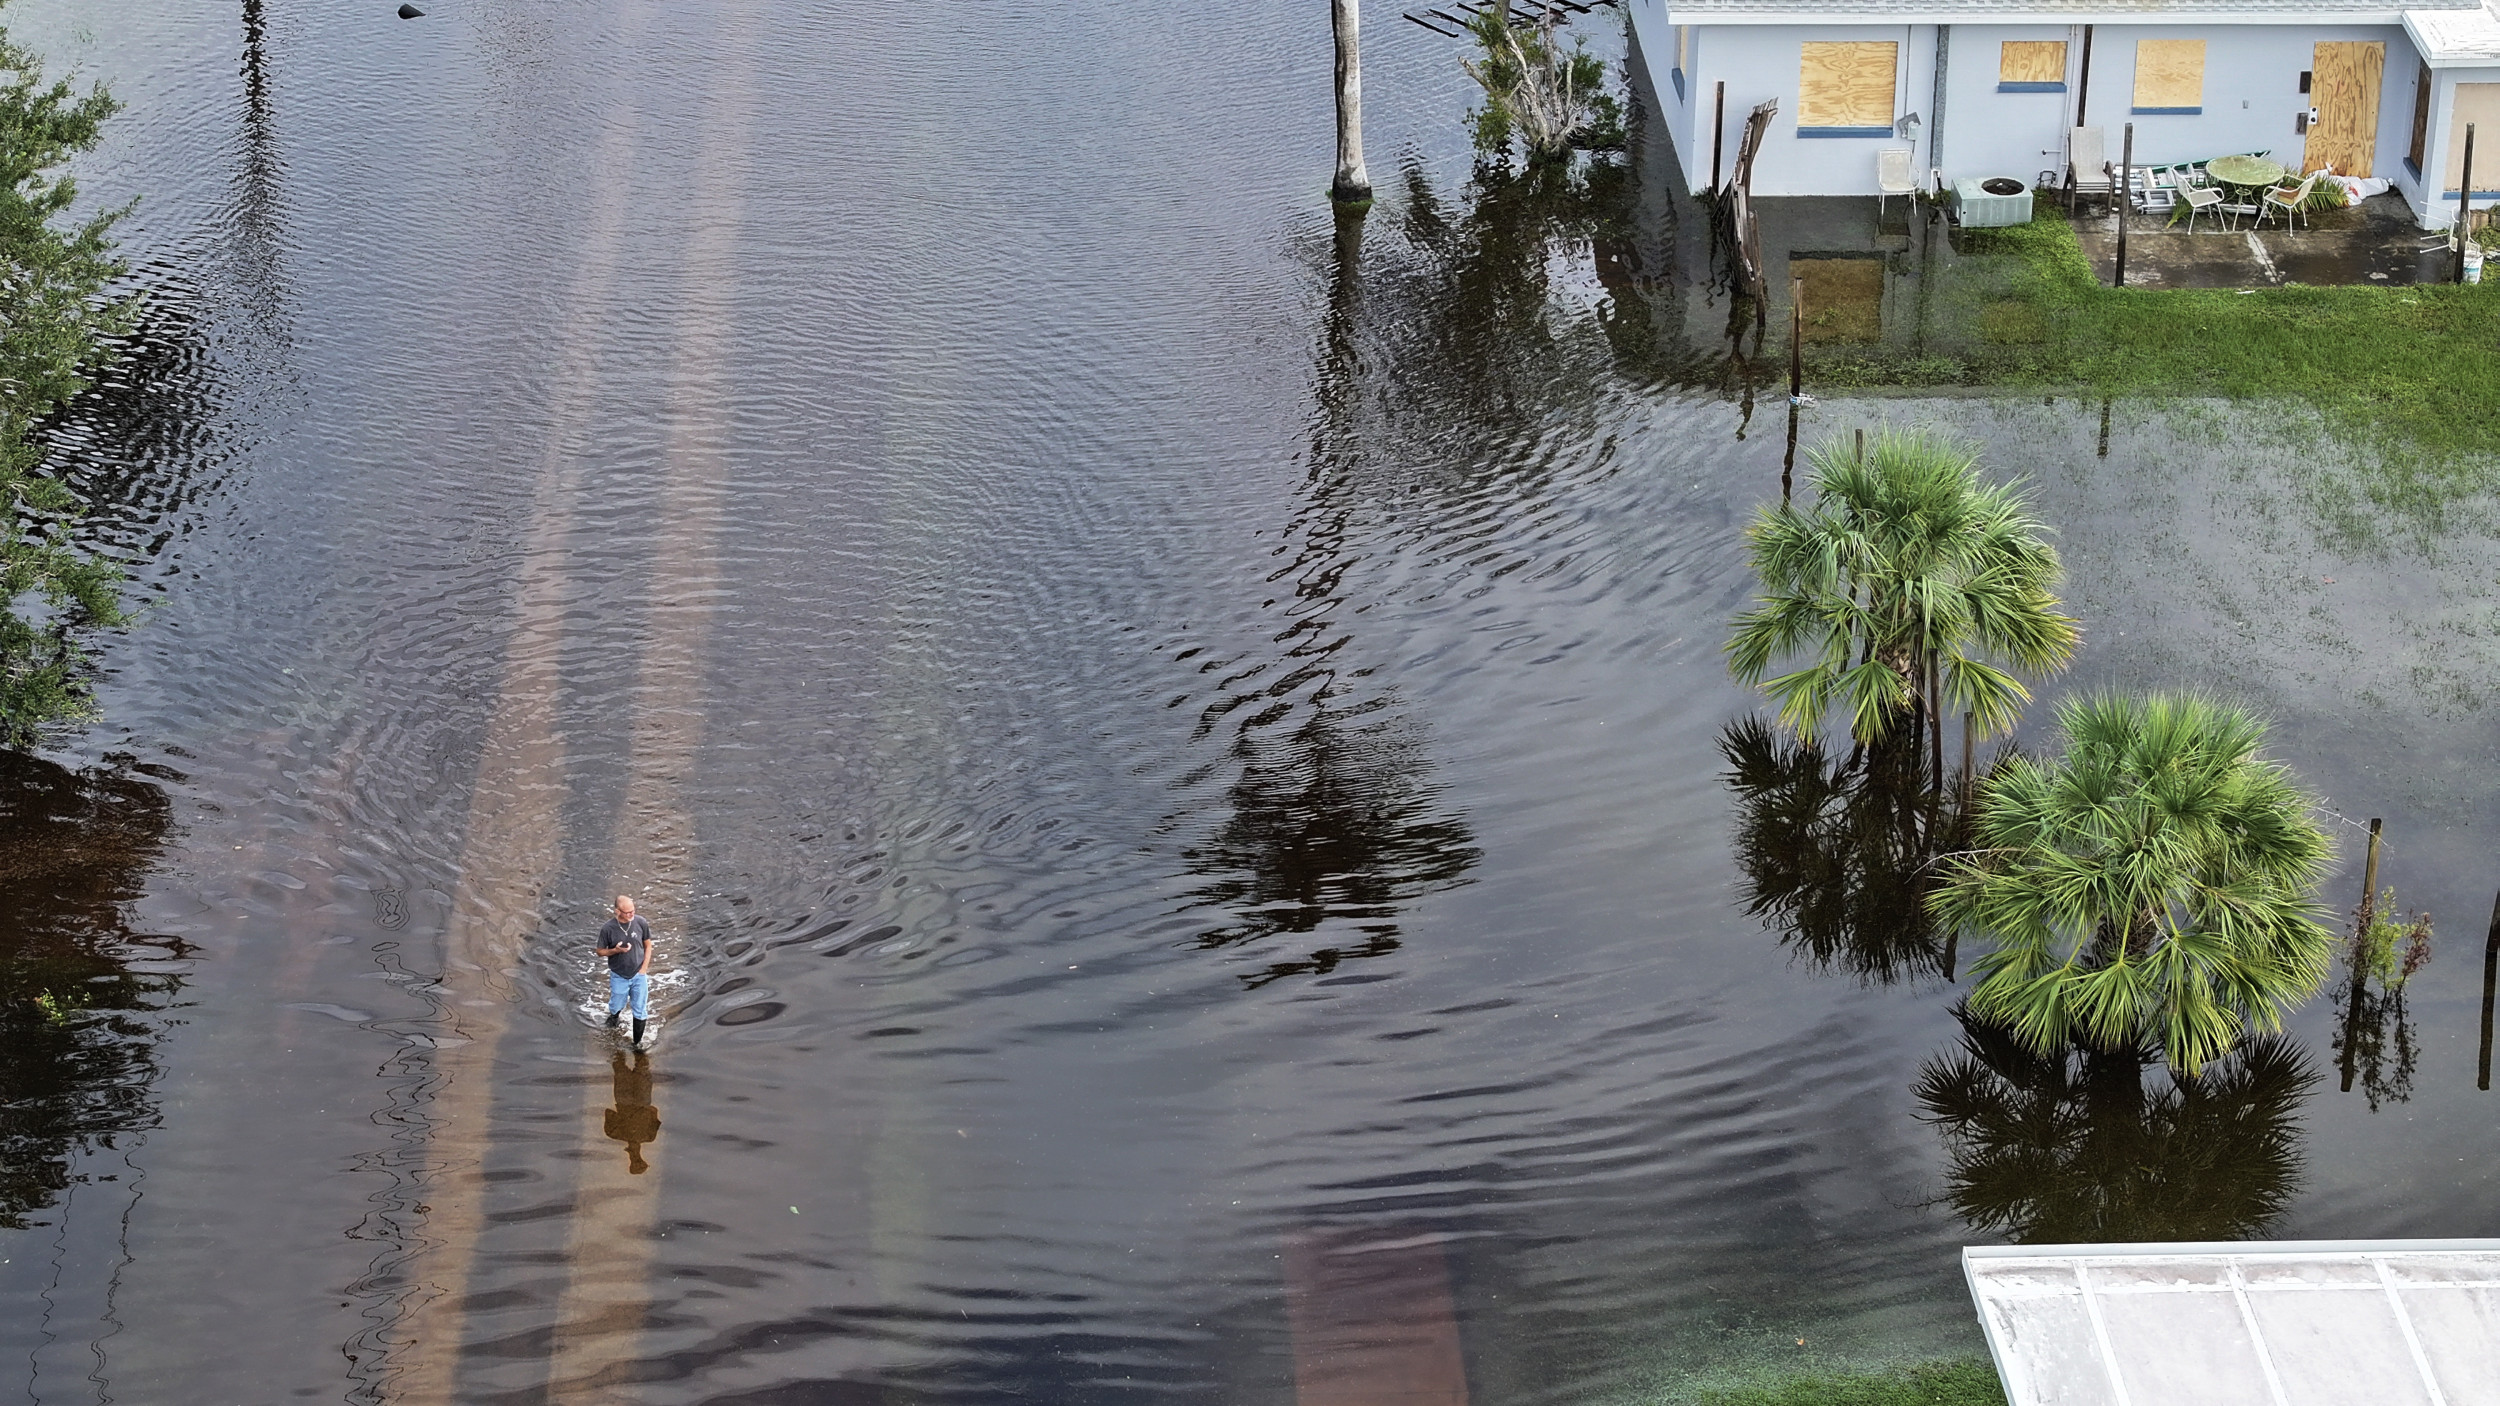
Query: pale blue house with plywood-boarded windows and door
1628 0 2500 228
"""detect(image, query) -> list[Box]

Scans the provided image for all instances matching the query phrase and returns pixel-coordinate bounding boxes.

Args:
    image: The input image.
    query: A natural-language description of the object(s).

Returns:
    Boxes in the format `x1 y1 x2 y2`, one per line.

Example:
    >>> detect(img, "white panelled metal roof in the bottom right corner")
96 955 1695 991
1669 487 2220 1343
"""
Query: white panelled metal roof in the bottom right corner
1963 1241 2500 1406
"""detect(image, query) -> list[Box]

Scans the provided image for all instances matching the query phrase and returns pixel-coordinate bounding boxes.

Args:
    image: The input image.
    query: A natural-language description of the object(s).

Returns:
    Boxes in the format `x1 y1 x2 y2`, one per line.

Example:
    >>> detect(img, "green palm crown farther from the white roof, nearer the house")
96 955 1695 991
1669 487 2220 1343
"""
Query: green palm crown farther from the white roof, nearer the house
1728 430 2078 755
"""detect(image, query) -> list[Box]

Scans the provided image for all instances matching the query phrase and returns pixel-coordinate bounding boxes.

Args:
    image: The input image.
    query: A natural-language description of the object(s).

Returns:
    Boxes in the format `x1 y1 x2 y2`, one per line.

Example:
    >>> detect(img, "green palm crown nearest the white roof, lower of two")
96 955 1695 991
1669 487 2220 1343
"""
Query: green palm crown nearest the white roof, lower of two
1930 695 2335 1073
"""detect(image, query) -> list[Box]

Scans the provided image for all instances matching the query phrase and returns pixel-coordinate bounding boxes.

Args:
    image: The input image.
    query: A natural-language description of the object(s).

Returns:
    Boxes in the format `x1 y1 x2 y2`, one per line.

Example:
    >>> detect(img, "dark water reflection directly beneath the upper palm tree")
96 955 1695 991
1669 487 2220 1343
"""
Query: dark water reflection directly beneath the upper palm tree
1720 718 1963 986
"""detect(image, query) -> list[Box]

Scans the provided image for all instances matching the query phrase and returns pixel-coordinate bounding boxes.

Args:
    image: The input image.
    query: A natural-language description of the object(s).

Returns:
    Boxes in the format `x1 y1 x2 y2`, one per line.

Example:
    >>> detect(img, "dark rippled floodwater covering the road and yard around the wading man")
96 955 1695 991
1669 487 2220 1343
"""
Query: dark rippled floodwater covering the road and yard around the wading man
0 0 2500 1406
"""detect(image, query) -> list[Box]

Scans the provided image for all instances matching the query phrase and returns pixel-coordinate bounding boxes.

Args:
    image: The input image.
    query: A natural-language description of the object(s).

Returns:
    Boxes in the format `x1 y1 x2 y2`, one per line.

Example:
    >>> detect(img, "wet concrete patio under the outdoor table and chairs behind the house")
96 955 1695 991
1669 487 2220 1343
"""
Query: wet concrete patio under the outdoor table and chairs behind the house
2075 195 2455 288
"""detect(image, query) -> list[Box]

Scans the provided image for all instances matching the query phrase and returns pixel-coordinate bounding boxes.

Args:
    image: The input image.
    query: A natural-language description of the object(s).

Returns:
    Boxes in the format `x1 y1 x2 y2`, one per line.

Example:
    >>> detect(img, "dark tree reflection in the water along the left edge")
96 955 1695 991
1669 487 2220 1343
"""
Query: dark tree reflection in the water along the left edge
0 753 188 1231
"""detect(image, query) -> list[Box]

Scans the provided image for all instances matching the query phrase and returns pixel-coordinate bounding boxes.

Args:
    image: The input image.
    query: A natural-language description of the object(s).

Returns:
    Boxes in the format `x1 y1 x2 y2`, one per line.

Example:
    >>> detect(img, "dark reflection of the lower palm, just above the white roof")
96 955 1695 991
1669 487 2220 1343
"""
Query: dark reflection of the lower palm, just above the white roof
1915 1011 2318 1243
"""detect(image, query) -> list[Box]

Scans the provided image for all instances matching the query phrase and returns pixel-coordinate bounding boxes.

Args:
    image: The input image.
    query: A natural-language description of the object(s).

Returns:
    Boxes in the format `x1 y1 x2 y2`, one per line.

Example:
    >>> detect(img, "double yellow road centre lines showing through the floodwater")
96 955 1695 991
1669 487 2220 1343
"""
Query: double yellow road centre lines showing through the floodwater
378 8 758 1380
